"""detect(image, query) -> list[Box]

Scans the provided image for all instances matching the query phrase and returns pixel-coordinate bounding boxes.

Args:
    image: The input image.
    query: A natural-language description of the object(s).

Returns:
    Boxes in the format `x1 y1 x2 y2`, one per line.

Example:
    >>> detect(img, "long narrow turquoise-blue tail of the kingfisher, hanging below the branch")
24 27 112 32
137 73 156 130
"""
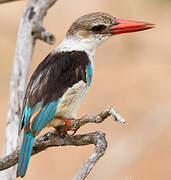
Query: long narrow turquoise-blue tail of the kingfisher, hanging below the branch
17 131 35 177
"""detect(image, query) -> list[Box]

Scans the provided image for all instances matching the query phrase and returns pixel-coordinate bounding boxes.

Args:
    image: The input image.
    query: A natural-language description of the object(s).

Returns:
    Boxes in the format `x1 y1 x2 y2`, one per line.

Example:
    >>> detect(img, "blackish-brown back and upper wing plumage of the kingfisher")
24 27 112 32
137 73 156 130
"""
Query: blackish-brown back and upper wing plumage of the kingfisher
20 51 90 129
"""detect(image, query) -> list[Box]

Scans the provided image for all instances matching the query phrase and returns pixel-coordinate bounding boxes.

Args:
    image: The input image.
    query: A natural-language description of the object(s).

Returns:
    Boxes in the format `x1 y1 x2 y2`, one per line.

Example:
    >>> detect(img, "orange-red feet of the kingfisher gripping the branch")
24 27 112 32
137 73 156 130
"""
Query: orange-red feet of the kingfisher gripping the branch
54 116 74 137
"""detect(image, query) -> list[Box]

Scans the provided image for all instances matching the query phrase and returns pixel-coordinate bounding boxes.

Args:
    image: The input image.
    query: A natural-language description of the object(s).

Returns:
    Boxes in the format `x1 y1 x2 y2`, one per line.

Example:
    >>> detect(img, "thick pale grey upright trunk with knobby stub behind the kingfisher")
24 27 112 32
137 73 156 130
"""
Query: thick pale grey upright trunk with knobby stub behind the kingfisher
0 0 56 180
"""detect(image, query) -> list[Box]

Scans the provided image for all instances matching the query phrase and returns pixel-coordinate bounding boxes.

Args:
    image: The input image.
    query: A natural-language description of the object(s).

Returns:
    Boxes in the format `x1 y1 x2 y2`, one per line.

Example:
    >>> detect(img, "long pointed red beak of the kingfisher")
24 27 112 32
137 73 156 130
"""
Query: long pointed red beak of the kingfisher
109 19 155 35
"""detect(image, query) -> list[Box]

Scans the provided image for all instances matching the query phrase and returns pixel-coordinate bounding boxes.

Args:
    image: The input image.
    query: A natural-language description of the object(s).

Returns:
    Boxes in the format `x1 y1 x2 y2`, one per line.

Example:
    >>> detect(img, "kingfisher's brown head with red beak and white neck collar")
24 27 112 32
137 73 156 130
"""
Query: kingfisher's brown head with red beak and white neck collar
56 12 154 57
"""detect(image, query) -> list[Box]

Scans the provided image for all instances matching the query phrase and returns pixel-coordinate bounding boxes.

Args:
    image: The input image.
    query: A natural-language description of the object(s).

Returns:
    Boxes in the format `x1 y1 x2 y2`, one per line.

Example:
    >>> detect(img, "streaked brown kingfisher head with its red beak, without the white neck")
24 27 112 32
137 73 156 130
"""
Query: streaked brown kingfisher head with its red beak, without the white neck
66 12 154 46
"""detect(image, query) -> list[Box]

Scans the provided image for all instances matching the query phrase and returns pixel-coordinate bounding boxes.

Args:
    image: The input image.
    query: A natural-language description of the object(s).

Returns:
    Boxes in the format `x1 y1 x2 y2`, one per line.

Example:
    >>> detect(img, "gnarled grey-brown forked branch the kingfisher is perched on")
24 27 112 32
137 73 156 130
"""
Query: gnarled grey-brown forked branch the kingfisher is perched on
0 107 125 180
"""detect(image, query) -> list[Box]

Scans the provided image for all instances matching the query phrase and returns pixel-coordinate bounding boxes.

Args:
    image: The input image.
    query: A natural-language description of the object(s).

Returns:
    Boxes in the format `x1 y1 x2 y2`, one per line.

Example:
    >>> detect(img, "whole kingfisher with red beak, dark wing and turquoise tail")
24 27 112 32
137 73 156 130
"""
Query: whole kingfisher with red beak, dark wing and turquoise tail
16 12 154 177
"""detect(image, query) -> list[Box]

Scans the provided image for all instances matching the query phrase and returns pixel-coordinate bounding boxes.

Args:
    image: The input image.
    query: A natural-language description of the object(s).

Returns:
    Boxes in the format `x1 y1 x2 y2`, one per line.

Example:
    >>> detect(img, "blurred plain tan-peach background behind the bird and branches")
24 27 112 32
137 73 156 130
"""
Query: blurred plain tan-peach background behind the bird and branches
0 0 171 180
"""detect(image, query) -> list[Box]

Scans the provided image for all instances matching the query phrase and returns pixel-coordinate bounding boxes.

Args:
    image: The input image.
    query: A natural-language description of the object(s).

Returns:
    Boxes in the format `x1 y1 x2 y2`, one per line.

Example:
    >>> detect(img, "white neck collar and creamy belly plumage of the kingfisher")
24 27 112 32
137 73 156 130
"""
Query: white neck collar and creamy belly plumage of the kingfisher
48 37 96 126
